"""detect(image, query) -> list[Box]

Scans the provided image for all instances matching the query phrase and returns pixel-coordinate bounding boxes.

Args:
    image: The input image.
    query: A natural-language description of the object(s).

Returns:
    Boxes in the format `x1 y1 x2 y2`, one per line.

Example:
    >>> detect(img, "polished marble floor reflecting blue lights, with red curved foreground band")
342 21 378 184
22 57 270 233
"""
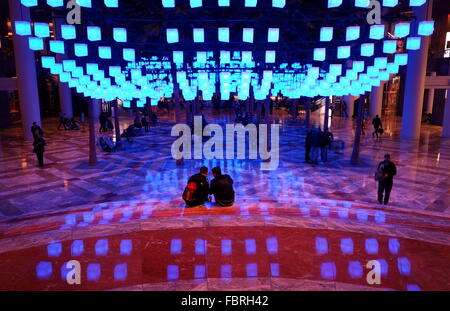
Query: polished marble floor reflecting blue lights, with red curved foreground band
0 111 450 290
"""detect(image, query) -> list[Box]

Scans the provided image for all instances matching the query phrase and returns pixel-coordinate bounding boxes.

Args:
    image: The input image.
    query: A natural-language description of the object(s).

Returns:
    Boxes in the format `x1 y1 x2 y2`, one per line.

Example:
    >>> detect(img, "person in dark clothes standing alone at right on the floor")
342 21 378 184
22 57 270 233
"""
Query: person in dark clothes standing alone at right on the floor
375 154 397 205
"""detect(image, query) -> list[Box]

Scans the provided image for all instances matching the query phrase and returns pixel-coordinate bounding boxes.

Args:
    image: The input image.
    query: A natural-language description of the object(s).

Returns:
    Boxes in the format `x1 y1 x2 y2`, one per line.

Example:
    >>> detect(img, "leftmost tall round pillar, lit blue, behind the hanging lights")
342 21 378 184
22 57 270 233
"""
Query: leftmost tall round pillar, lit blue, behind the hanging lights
9 0 41 140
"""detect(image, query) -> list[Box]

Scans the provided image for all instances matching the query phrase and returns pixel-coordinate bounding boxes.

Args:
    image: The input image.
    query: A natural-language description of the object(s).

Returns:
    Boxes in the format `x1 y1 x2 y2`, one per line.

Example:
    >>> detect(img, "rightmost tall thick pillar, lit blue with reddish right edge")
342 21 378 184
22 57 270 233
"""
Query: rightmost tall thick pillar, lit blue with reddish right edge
401 0 433 139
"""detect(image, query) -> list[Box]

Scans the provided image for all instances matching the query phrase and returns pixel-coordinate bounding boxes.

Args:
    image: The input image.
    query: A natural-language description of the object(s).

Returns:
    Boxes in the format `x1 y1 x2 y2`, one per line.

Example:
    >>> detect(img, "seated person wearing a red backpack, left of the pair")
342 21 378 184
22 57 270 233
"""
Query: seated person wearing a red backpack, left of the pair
183 166 209 207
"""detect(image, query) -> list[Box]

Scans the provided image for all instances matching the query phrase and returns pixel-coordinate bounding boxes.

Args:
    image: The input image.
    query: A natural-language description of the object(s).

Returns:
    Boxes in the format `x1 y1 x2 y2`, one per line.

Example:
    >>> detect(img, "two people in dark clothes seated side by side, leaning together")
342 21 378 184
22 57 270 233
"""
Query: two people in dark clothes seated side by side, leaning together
183 166 234 207
